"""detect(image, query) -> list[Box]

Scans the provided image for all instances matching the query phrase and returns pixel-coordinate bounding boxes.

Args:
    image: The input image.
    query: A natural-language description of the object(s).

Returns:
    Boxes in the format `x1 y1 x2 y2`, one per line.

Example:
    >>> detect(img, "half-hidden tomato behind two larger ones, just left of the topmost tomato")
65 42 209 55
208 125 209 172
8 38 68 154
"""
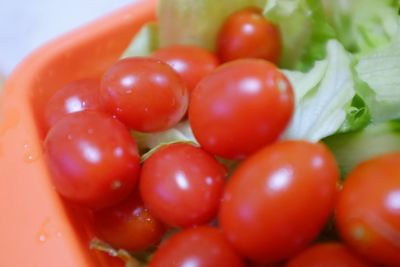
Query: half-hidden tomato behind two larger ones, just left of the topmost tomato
153 45 219 92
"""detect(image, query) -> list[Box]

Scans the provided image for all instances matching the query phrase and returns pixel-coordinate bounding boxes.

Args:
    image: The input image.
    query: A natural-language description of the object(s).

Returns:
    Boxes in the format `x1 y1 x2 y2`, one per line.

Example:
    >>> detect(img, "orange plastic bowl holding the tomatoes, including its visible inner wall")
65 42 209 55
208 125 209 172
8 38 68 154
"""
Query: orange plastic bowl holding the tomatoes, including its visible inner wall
0 0 156 267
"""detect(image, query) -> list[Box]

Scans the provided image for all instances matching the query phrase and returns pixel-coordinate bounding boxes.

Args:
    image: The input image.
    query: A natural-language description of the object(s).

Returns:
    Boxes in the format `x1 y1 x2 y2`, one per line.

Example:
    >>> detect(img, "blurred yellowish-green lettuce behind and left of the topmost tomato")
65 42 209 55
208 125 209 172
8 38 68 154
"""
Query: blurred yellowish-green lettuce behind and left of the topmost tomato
158 0 266 51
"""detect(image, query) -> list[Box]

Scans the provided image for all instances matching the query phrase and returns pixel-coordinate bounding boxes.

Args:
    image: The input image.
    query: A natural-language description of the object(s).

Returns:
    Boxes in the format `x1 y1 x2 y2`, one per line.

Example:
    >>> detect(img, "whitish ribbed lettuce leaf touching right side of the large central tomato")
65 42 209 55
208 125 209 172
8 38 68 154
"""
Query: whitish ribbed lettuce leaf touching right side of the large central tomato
284 40 355 141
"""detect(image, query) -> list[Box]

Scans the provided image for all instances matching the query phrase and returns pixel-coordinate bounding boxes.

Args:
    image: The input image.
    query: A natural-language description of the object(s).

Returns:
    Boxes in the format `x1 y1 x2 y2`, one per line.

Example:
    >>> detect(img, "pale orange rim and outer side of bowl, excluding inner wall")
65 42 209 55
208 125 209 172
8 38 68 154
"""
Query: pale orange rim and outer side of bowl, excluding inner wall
0 0 157 267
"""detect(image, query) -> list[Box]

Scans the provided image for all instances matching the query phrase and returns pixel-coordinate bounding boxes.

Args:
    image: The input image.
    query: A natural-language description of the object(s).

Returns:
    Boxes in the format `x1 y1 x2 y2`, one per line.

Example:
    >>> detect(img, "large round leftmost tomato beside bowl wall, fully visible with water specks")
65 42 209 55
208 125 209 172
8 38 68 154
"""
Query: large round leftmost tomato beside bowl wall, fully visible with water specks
44 110 140 208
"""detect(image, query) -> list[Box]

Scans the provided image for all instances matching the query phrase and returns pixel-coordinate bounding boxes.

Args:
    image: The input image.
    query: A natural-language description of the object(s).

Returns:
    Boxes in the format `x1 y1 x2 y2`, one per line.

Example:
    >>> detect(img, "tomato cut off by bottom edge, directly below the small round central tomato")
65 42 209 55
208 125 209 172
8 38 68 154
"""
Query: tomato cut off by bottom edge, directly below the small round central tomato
148 226 245 267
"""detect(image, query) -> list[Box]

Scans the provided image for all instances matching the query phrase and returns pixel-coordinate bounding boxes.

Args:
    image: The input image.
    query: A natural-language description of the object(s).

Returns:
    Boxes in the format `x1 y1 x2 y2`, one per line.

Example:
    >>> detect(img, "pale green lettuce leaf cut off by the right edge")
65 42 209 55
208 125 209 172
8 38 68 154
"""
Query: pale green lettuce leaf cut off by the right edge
355 26 400 123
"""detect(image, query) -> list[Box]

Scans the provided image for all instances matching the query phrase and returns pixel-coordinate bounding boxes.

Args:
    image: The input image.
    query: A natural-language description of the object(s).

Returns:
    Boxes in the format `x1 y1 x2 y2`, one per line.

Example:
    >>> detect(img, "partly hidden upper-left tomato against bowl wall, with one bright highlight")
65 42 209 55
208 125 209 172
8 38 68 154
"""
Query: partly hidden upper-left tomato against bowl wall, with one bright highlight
44 79 105 131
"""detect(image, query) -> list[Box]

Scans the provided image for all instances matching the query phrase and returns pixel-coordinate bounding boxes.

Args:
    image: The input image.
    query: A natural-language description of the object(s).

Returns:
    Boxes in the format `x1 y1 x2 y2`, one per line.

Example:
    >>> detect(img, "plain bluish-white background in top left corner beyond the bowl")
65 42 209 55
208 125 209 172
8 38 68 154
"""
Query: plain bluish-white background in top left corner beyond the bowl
0 0 135 74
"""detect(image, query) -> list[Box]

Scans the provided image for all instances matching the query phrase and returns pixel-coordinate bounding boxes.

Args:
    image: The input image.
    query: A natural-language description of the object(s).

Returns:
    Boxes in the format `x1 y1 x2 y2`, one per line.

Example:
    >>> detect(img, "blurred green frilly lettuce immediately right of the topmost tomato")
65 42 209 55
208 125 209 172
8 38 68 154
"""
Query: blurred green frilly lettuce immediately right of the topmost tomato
264 0 335 71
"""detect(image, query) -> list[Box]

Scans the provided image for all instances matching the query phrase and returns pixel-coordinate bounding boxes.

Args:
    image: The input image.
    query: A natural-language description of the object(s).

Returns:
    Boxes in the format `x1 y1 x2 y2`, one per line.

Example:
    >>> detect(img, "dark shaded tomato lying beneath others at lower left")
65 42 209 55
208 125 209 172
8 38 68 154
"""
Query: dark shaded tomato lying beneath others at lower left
94 193 166 251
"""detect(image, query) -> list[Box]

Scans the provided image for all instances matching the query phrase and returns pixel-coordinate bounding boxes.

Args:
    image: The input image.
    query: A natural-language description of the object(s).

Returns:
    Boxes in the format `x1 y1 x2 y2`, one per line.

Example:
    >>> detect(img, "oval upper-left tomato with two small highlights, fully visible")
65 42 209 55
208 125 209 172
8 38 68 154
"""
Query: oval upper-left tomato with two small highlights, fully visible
100 57 188 132
